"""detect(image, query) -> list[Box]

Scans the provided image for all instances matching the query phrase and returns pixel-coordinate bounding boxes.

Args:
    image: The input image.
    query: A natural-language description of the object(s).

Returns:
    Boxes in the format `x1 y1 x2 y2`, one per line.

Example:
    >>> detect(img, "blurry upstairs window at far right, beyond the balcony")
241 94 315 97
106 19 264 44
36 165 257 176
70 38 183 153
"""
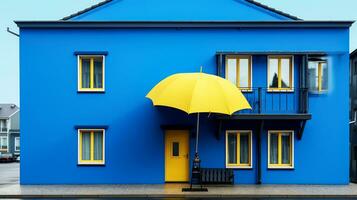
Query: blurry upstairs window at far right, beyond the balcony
308 61 328 92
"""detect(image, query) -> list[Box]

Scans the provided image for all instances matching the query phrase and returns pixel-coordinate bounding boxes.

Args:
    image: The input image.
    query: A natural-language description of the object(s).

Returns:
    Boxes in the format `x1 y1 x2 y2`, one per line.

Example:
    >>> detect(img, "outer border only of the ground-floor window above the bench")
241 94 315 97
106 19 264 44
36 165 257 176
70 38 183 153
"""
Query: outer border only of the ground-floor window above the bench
225 130 253 169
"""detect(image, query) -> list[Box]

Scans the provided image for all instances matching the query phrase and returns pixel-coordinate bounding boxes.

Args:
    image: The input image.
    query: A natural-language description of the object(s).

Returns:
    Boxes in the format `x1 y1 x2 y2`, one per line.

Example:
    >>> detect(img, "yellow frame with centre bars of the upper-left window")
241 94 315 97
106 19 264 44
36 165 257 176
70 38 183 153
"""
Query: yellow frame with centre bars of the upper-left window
78 55 105 92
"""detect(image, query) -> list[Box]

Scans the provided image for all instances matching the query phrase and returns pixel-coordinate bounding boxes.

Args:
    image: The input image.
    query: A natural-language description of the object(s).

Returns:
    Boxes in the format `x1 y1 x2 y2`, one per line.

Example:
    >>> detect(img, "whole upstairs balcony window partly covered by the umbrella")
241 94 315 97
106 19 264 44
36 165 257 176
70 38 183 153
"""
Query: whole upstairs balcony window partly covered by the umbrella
226 56 252 91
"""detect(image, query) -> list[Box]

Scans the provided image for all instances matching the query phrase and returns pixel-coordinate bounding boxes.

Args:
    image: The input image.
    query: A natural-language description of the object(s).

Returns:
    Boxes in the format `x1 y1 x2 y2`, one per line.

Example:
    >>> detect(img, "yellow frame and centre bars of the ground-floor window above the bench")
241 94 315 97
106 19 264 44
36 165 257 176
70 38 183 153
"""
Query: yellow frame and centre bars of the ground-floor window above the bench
226 130 253 168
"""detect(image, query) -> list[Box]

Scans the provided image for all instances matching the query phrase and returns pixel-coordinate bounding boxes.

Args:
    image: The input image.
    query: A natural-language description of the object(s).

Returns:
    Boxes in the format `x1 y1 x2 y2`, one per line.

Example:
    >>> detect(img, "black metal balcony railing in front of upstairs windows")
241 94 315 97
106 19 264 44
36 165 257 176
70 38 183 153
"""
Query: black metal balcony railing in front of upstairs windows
237 87 309 114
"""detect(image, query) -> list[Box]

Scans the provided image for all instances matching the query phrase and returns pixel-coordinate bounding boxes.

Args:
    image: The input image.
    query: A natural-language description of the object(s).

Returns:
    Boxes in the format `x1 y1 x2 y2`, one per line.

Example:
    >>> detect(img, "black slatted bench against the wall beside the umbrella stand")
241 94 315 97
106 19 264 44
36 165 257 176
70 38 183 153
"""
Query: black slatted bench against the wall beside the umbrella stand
201 168 234 185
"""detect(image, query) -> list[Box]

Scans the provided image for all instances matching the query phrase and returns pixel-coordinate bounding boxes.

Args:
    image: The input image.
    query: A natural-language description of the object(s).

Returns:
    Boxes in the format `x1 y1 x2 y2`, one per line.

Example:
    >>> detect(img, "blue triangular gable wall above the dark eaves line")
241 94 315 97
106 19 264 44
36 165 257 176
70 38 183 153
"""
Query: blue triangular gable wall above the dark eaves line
72 0 291 21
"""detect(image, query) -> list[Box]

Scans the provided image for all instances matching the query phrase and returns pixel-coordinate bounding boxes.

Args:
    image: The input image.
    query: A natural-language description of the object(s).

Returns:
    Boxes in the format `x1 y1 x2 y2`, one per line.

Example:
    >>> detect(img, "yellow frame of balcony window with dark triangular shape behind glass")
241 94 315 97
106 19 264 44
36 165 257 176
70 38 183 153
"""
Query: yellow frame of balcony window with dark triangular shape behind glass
267 55 294 92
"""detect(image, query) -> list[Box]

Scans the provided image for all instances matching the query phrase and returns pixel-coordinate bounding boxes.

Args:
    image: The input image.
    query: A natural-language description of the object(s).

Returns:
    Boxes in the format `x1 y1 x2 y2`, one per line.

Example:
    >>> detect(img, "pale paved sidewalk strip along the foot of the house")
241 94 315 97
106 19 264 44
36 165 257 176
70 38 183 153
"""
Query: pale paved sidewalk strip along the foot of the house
0 183 357 198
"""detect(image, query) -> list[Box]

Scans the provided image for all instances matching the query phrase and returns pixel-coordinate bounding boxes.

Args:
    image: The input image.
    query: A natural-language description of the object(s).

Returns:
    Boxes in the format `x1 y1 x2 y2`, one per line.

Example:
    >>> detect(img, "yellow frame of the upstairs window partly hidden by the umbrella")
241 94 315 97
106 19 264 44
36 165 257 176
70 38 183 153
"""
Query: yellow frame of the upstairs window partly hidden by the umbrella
225 55 252 92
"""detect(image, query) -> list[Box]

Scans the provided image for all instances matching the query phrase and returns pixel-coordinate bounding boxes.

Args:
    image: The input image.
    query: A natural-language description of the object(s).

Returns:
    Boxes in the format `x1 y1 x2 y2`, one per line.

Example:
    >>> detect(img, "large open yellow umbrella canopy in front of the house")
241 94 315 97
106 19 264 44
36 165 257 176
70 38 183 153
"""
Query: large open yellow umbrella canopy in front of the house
146 72 251 115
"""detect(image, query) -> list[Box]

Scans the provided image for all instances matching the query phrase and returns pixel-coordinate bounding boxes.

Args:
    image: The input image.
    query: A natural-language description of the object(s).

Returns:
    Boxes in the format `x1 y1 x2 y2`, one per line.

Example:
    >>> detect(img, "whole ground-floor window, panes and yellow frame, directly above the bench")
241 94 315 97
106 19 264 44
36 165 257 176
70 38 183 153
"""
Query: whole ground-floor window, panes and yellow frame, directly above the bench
226 130 252 168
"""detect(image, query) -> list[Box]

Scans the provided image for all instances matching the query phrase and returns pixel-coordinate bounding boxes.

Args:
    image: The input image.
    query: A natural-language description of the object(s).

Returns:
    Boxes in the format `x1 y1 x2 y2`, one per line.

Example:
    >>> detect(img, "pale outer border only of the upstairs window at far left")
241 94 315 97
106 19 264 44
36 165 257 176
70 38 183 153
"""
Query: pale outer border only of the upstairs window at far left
77 54 105 93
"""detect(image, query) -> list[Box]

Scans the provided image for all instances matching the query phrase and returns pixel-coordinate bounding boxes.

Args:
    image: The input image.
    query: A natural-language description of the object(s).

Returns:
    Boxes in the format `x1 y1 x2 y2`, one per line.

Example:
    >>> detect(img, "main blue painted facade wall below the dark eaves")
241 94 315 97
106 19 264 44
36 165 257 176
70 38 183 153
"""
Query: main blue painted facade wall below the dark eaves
20 25 349 184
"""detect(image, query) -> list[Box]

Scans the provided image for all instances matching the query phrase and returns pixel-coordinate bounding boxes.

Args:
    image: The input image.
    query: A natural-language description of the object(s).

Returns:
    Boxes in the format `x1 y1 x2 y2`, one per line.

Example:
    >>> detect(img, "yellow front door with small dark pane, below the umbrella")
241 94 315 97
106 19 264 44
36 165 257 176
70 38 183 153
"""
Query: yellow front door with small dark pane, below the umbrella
165 130 189 182
